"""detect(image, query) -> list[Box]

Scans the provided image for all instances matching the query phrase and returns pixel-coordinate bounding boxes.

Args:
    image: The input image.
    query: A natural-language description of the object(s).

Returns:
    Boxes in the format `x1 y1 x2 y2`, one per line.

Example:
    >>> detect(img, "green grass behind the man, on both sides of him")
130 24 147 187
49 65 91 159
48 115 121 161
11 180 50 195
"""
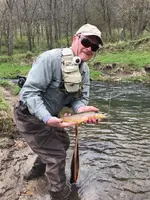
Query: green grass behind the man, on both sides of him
0 37 150 80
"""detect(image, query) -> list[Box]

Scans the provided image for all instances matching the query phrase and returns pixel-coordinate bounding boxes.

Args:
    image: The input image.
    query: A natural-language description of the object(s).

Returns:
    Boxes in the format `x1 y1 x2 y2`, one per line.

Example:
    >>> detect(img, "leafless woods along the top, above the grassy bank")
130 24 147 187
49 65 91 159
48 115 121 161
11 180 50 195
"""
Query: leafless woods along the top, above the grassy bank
0 0 150 55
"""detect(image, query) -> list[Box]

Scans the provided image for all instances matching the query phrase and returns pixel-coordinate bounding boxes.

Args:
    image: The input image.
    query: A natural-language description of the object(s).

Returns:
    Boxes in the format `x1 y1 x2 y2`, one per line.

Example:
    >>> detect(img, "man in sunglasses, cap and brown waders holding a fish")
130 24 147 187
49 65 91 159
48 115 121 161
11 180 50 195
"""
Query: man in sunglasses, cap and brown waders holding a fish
14 24 103 200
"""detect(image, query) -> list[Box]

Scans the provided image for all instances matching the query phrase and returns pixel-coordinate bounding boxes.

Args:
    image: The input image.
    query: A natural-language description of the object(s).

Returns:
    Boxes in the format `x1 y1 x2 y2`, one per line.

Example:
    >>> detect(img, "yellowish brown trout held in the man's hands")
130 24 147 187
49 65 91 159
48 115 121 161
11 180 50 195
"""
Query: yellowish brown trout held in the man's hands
61 111 107 124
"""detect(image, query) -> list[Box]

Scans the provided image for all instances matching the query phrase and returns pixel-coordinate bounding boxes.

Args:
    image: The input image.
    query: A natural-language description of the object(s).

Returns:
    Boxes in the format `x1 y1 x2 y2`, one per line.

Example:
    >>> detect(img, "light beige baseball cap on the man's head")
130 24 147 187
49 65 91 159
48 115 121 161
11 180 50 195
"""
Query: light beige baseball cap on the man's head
76 24 103 46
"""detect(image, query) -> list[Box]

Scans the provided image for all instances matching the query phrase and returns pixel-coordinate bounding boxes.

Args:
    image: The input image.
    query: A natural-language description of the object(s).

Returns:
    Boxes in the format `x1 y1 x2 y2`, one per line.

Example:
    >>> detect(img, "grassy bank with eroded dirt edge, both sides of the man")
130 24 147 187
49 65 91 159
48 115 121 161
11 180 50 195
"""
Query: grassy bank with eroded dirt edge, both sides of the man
0 38 150 83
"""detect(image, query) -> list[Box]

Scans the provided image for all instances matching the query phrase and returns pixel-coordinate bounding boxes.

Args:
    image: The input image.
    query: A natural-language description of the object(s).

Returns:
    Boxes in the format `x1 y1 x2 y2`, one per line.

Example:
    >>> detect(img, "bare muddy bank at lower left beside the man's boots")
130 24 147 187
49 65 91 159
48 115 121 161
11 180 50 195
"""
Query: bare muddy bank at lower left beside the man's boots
0 89 50 200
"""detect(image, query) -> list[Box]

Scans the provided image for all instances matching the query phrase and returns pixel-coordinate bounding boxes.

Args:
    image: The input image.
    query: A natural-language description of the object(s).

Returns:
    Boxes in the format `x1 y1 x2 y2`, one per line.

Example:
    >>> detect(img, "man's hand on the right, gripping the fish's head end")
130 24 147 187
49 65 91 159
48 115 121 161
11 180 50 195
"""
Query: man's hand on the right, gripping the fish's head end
77 106 99 124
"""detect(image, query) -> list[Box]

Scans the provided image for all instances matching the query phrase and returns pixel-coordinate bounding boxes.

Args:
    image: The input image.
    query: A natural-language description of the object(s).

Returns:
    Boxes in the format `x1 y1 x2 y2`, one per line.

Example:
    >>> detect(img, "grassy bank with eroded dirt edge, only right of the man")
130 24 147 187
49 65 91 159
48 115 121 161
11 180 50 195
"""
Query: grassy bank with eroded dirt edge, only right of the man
89 38 150 83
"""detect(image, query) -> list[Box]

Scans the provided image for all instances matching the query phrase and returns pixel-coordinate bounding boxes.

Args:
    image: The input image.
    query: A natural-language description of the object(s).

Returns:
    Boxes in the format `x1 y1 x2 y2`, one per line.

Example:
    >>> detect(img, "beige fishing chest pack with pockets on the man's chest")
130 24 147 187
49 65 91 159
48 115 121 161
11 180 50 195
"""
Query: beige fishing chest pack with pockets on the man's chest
61 48 82 93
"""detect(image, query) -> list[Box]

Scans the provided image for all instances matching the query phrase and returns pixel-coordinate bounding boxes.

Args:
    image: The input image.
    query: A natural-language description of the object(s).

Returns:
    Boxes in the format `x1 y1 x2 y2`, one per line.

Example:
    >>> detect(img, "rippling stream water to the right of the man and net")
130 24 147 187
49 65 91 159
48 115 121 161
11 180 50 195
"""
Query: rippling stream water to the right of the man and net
68 82 150 200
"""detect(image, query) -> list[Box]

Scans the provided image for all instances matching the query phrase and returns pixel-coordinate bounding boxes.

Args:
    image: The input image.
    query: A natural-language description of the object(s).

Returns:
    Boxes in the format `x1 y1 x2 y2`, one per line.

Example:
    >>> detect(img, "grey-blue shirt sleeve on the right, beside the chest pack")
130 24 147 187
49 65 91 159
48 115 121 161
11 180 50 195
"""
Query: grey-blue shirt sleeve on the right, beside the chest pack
71 63 90 113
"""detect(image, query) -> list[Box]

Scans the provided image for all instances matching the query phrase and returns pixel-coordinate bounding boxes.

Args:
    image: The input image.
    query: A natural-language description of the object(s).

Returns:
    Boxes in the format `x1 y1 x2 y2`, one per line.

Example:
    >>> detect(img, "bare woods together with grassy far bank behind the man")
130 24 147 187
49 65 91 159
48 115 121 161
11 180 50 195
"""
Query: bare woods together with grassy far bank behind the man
0 0 150 84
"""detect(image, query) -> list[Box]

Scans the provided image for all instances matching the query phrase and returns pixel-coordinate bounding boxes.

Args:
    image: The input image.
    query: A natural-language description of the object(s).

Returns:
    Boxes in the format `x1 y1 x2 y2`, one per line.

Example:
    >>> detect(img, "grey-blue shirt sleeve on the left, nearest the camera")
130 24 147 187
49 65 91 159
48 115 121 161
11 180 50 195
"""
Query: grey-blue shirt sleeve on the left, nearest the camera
20 51 53 122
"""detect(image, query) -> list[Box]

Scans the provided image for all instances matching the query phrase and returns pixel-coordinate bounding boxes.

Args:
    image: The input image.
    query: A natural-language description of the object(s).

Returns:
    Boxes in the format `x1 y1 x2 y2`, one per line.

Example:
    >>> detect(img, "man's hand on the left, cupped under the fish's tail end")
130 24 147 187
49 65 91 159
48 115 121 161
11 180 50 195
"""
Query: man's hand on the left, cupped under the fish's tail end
46 117 75 128
